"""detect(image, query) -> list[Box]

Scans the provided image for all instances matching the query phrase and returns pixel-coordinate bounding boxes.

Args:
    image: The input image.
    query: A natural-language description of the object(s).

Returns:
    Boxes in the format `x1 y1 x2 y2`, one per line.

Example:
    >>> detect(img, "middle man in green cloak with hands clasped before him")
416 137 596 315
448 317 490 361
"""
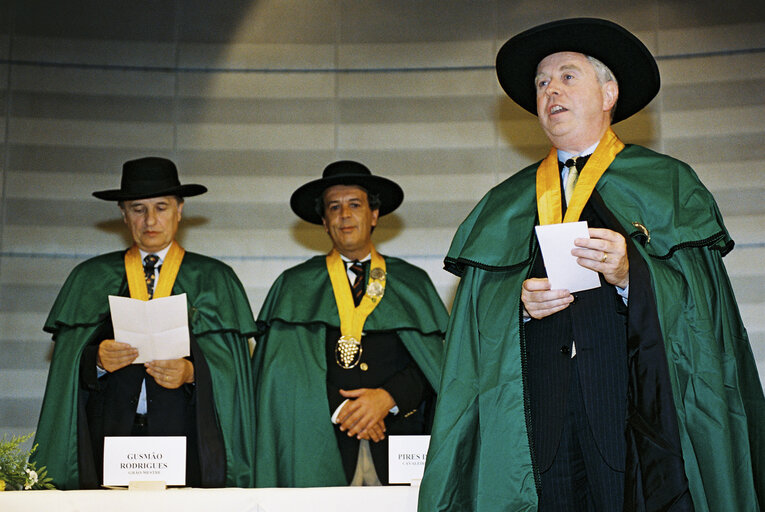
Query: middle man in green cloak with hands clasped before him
255 160 447 487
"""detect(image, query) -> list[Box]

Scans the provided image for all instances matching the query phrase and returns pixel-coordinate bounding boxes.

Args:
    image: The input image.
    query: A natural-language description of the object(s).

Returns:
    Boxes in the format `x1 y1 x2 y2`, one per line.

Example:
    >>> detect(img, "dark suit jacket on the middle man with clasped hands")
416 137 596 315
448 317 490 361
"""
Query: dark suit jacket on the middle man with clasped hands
326 328 434 484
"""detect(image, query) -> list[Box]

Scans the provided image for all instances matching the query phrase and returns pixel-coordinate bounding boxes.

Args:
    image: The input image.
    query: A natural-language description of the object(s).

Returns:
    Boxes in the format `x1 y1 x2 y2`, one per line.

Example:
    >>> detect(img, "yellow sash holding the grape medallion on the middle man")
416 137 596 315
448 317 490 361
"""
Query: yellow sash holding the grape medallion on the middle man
326 246 385 341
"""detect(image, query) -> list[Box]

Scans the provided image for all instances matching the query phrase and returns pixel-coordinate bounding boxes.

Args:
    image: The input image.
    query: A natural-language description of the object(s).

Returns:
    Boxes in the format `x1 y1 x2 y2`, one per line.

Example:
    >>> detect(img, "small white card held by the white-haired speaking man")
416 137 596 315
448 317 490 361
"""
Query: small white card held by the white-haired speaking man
535 221 600 293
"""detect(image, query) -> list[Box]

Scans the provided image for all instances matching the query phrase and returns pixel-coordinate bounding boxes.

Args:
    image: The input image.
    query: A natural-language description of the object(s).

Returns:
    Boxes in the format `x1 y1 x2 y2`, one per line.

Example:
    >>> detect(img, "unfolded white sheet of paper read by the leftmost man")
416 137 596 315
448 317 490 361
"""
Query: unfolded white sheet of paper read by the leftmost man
109 293 190 364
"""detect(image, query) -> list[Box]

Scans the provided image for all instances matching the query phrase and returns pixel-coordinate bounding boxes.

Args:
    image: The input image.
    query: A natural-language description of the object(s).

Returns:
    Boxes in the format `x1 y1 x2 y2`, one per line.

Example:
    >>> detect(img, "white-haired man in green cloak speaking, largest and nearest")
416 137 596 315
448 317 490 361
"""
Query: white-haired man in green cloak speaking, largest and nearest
419 18 765 512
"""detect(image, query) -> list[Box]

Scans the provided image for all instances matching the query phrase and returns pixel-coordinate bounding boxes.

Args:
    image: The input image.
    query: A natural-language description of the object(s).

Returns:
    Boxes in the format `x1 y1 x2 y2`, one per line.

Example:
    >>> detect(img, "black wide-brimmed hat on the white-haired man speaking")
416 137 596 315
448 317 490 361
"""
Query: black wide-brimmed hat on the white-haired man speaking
497 18 660 123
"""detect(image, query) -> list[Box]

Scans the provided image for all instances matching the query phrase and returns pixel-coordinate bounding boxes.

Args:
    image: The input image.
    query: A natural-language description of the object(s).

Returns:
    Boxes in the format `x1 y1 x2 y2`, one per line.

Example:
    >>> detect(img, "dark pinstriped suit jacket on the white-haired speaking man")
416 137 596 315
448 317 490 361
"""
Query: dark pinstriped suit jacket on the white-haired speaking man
524 203 627 471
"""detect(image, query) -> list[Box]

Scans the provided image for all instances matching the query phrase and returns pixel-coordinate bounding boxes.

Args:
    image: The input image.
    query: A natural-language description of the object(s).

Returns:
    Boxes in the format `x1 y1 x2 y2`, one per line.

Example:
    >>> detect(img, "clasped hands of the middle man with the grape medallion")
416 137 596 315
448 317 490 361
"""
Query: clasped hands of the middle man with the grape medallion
337 388 396 442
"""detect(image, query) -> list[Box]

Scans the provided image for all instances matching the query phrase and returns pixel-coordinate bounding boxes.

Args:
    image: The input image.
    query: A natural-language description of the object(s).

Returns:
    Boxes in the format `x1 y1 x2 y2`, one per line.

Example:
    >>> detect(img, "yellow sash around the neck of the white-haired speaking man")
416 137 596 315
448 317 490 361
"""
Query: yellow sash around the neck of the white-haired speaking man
537 128 624 225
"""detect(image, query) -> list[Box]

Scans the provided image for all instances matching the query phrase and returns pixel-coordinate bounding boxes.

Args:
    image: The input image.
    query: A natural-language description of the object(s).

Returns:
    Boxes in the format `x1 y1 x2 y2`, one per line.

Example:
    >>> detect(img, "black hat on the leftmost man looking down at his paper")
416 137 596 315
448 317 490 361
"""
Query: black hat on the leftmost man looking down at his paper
93 156 207 201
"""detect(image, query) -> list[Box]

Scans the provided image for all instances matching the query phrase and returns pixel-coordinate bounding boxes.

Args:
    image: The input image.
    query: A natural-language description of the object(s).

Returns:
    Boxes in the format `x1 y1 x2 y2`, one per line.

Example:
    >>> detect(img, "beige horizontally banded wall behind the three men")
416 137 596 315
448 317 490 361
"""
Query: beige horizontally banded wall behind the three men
0 0 765 440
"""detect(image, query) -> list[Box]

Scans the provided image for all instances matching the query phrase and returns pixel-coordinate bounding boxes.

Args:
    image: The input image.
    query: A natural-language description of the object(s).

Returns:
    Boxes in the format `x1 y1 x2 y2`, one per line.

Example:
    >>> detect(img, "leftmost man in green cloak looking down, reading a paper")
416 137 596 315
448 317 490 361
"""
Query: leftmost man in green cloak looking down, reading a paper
35 157 255 489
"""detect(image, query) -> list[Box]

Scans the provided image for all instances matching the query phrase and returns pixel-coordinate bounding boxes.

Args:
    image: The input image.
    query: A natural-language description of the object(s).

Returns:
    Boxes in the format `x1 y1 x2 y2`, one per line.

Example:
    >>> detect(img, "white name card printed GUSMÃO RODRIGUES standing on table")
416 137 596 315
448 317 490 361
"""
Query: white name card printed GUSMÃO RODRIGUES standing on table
104 436 186 486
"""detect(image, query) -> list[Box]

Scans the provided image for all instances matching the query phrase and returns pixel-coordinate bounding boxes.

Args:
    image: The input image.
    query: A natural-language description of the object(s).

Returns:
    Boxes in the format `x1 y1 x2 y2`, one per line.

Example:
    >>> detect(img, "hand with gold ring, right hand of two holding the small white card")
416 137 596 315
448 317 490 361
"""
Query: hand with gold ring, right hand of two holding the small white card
571 228 630 289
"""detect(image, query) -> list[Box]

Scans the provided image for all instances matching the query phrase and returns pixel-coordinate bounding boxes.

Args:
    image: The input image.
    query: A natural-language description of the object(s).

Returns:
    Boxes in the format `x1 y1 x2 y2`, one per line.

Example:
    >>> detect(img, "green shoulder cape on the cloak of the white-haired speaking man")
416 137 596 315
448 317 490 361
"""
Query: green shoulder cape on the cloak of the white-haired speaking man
446 145 733 275
